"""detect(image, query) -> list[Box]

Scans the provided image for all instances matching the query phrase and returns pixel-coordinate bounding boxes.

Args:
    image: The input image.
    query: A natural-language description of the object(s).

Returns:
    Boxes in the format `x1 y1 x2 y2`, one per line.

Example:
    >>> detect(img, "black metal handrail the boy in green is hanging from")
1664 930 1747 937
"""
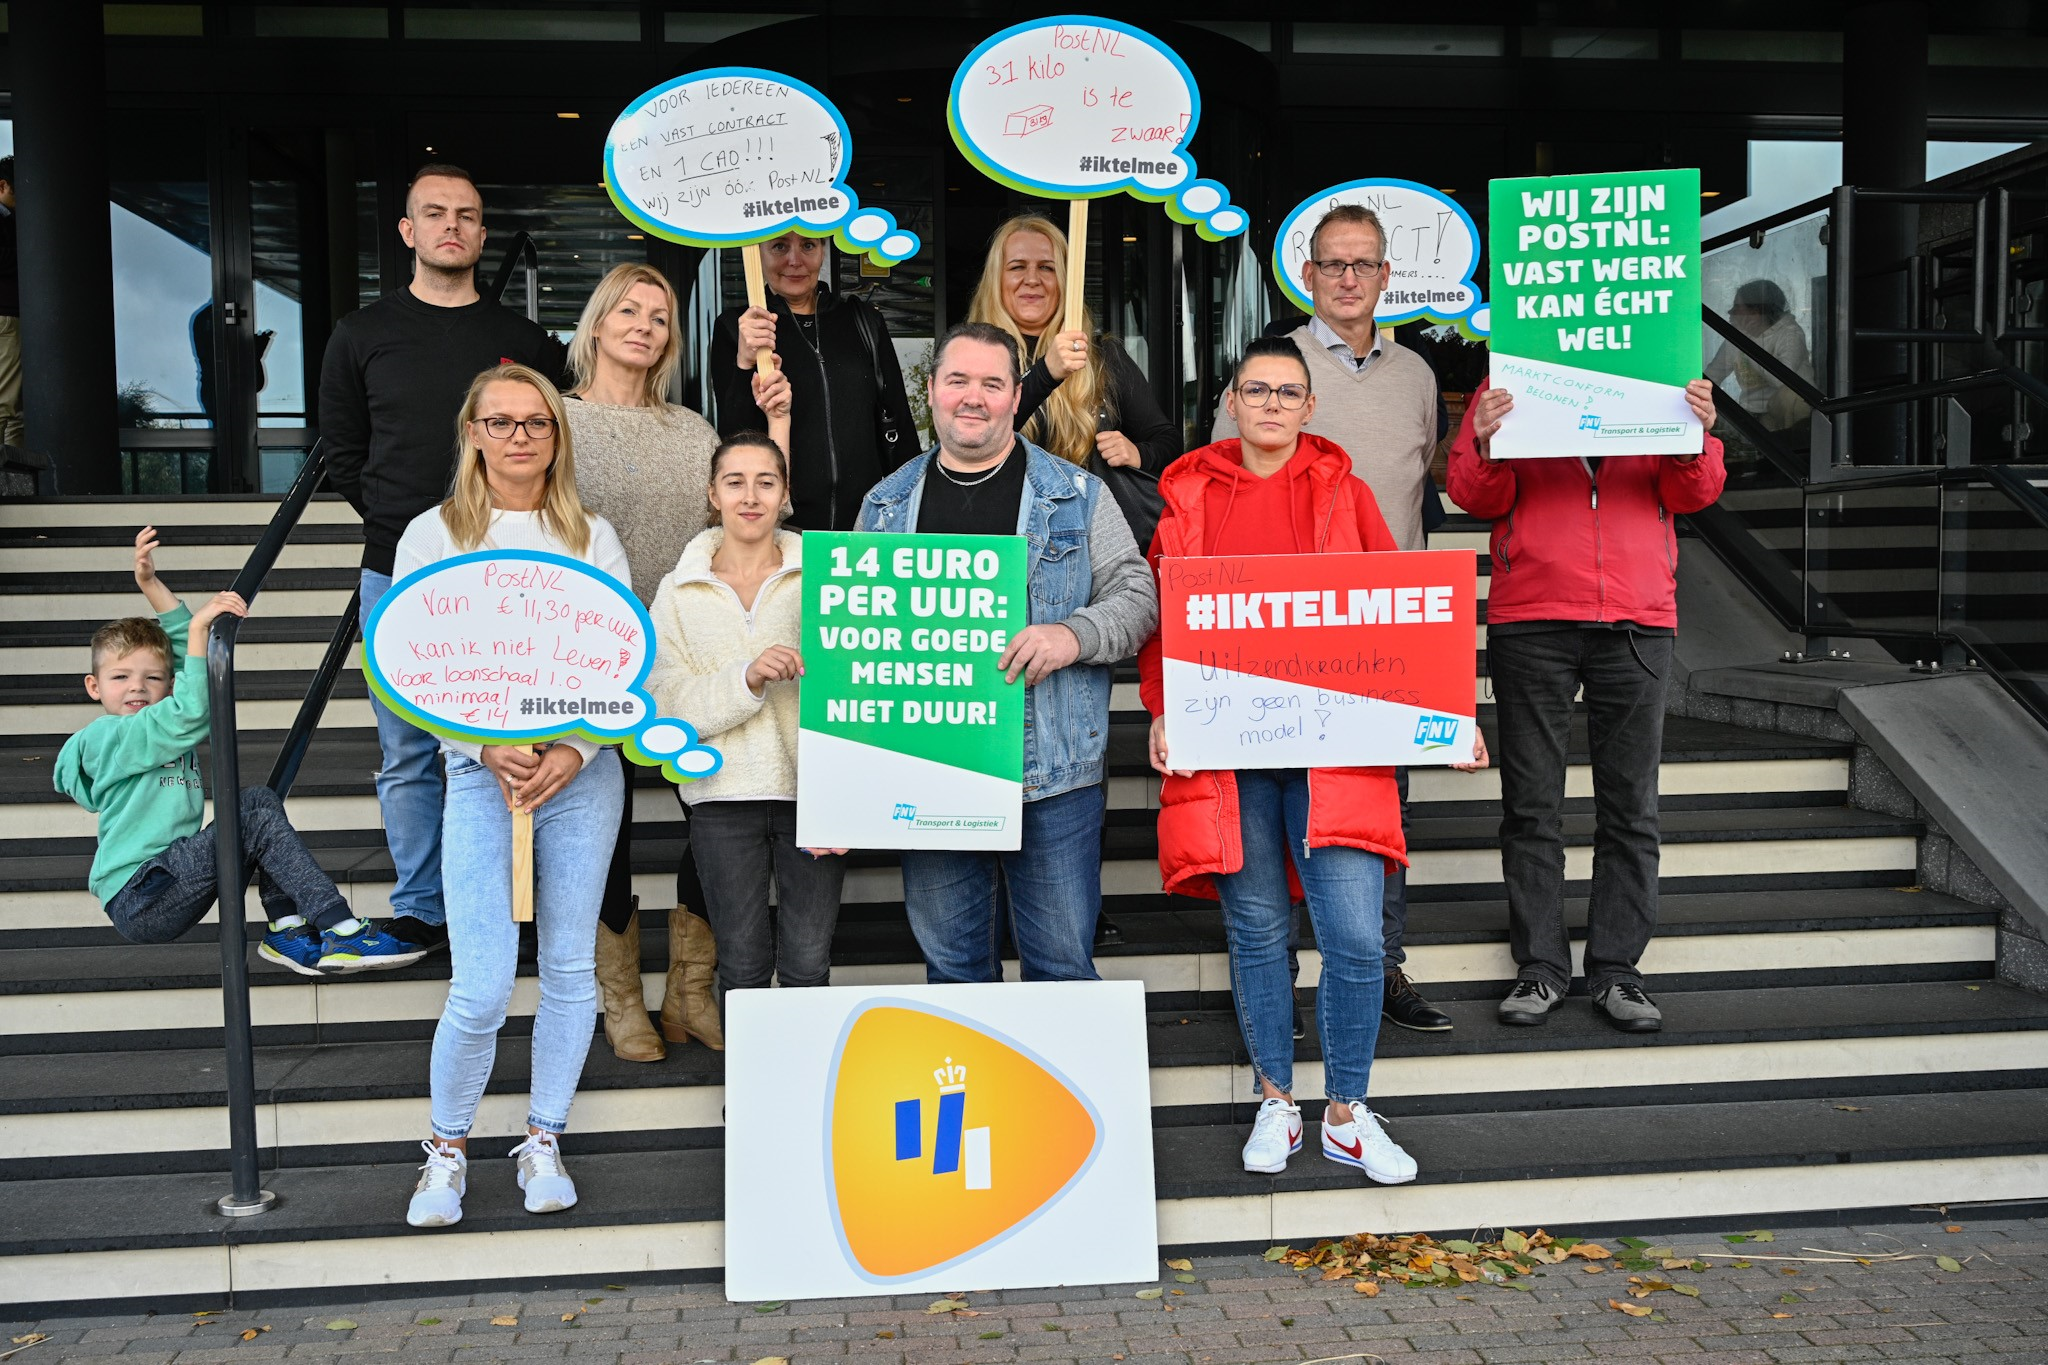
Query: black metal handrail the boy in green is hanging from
207 442 331 1218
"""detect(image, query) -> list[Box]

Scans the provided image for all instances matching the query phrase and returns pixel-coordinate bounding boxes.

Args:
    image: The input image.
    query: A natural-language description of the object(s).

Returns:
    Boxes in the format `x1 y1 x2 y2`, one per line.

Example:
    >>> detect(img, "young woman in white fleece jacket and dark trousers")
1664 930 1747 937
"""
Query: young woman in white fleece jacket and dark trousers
647 434 846 1011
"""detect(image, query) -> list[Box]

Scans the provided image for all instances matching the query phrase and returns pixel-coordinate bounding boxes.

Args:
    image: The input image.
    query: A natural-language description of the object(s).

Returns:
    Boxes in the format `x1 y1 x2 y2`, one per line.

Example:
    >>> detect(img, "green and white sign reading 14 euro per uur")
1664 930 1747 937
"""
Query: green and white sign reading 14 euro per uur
797 530 1030 849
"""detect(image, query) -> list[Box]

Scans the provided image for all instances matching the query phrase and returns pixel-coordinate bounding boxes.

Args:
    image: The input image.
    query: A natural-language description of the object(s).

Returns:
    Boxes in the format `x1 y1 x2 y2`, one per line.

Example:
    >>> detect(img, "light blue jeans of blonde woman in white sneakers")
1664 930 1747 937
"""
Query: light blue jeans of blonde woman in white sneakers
432 749 625 1138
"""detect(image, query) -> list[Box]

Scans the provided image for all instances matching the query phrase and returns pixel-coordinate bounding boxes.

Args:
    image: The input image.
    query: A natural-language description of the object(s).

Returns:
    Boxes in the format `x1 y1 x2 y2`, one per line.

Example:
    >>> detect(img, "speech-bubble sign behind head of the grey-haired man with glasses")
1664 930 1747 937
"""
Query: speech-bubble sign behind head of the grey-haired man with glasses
1274 178 1487 338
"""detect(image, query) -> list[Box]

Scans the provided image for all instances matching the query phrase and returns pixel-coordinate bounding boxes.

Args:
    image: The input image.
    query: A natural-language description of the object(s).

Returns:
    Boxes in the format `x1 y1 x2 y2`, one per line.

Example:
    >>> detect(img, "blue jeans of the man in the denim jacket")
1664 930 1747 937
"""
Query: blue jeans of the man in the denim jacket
903 784 1102 986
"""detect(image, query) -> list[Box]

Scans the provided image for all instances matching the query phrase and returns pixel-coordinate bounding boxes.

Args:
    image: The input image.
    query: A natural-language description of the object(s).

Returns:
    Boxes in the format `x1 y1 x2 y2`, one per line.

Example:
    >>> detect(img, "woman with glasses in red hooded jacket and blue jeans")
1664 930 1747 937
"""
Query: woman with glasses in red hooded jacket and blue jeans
1139 338 1490 1185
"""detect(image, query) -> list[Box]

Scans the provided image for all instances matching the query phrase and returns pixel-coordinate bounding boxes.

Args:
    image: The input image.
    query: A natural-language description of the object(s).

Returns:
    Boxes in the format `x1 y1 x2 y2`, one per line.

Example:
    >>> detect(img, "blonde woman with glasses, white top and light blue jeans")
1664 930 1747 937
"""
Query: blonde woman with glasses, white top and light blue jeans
393 364 631 1228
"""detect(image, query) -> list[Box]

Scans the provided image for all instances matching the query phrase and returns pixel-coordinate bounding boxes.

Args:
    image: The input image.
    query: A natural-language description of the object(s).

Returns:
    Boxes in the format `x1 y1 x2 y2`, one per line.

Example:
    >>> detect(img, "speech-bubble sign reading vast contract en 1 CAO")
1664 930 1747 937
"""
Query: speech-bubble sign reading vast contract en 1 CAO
604 65 918 266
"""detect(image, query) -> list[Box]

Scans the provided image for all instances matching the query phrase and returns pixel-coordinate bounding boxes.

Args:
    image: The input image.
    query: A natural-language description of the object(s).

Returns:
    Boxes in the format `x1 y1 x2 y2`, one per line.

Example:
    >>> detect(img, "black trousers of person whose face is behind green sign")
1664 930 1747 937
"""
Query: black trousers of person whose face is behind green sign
1487 628 1673 995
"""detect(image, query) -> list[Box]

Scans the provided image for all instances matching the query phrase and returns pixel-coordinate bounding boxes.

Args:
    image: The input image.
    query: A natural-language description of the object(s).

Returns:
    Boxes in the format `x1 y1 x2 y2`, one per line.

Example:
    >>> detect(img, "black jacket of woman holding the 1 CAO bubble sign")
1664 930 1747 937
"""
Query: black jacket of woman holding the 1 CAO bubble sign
711 286 918 530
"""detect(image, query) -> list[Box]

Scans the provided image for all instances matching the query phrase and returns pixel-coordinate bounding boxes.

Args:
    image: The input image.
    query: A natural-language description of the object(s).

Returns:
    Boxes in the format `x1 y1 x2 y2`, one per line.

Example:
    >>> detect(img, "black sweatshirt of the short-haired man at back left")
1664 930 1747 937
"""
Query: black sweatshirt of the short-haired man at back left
319 289 567 573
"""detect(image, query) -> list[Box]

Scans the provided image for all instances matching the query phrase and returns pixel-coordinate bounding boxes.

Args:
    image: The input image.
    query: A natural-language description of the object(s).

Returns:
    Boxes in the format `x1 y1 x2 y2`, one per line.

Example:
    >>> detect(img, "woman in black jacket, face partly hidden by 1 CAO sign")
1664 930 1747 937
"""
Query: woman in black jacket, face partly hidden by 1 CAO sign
711 231 918 530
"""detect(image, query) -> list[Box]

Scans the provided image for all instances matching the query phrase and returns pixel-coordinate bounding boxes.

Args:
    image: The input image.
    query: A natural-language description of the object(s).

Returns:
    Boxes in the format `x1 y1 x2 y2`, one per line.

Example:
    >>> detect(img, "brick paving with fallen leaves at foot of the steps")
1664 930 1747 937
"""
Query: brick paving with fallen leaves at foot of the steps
0 1214 2048 1365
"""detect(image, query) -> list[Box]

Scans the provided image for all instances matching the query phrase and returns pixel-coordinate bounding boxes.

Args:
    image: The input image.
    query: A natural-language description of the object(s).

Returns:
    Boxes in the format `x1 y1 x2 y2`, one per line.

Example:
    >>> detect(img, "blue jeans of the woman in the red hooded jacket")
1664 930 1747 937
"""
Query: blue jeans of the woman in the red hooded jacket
1217 767 1386 1105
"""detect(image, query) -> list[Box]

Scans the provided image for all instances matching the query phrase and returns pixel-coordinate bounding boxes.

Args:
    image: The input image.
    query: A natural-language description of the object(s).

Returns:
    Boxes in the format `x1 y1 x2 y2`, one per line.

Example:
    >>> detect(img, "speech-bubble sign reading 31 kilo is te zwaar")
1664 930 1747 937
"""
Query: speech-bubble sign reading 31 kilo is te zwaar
946 14 1251 241
